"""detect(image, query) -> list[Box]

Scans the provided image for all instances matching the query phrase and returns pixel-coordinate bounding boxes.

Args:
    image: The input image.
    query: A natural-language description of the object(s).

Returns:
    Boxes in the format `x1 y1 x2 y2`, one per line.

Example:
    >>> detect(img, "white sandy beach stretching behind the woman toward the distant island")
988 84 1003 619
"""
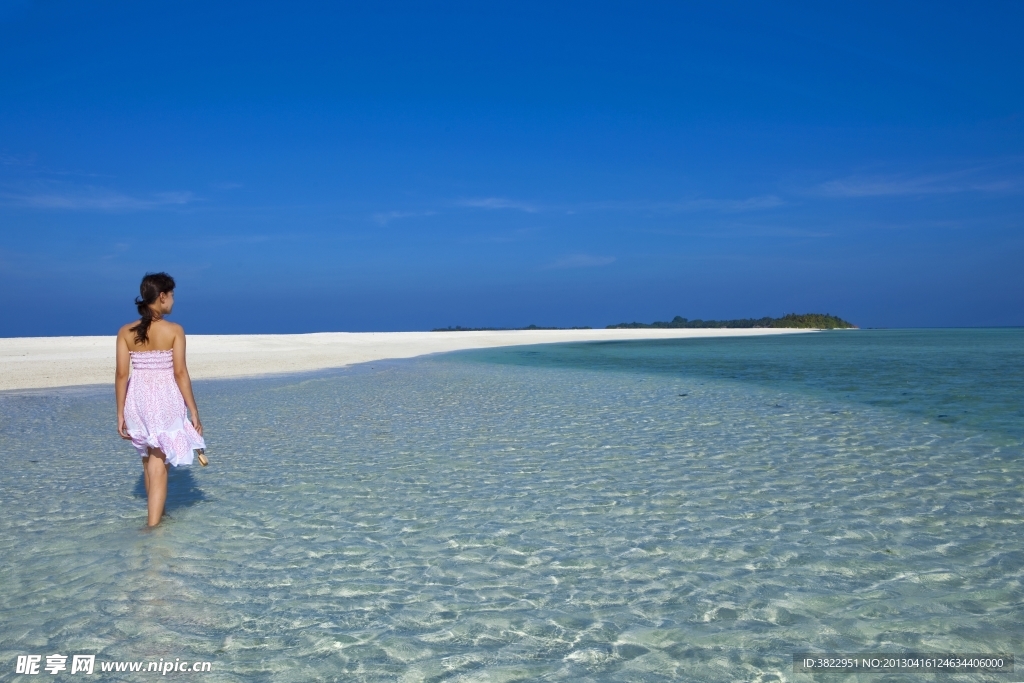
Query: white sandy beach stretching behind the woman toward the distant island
0 329 811 391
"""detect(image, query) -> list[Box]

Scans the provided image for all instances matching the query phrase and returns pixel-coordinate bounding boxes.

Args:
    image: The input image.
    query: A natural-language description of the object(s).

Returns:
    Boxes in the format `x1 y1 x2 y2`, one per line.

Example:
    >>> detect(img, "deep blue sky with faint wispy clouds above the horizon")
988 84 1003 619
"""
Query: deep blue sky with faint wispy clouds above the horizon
0 0 1024 336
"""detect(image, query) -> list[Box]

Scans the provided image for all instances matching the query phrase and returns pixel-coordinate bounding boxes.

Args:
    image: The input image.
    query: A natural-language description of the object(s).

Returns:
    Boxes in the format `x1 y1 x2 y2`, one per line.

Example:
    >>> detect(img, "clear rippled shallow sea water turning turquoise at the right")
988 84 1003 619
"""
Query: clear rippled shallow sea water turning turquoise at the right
0 330 1024 682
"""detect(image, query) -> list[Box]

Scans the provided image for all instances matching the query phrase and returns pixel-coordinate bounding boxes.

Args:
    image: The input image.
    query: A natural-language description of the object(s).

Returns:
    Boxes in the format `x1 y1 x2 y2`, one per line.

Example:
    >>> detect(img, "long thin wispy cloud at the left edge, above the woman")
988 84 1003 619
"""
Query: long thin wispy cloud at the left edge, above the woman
0 184 198 211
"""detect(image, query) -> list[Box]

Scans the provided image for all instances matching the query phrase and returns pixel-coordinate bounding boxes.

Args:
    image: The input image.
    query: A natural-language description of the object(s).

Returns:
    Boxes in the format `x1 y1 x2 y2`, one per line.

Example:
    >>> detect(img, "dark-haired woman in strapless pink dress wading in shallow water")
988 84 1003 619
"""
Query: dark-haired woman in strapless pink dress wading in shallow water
114 272 206 526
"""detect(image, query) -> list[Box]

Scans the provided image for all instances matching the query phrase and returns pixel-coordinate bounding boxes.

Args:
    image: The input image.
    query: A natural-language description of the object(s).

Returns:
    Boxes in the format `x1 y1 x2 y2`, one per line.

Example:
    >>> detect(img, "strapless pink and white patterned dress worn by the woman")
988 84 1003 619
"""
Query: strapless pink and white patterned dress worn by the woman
125 349 206 467
